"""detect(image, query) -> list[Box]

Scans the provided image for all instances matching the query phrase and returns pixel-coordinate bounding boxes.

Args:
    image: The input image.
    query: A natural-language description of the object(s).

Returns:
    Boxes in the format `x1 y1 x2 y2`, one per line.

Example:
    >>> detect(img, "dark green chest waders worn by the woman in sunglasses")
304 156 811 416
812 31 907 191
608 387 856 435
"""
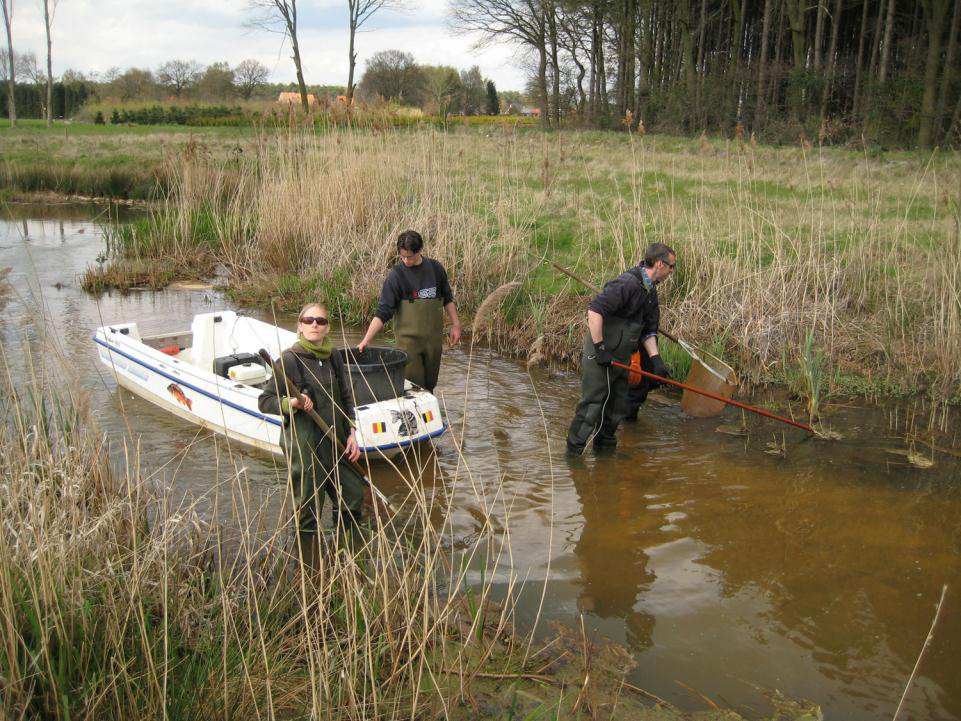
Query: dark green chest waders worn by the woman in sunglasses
280 351 364 565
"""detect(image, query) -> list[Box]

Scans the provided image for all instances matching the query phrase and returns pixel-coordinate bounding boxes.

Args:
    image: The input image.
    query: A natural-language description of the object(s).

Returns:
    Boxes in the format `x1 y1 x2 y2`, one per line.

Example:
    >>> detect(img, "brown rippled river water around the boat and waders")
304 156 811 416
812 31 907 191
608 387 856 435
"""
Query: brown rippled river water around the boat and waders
0 207 961 720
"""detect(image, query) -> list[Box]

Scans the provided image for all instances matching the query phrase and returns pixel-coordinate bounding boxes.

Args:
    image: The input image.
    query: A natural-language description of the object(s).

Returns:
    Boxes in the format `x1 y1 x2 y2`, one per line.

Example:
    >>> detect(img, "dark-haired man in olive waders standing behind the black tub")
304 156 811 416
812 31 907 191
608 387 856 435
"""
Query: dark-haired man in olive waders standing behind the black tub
357 230 461 393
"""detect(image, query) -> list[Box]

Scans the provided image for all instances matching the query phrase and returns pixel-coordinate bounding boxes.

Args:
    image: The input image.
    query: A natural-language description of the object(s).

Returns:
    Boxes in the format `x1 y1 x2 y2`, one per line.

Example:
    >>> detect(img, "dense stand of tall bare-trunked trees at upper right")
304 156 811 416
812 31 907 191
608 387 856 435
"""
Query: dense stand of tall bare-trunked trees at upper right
450 0 961 147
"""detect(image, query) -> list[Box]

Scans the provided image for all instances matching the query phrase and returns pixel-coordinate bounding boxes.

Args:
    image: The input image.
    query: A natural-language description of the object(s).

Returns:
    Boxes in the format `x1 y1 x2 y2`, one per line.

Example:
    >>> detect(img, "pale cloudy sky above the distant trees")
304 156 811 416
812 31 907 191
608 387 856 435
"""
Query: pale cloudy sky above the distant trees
7 0 523 90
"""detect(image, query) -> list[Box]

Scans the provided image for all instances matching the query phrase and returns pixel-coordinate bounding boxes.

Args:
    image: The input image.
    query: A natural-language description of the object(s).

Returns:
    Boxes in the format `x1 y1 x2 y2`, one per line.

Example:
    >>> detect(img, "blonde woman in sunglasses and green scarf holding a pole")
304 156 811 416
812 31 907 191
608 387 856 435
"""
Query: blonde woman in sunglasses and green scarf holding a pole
258 303 364 567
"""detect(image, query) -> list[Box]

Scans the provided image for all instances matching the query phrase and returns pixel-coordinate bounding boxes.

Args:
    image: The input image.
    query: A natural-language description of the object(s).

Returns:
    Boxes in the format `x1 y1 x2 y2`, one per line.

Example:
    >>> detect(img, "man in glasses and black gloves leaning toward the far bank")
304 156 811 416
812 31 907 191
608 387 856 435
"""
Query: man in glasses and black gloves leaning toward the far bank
567 243 677 456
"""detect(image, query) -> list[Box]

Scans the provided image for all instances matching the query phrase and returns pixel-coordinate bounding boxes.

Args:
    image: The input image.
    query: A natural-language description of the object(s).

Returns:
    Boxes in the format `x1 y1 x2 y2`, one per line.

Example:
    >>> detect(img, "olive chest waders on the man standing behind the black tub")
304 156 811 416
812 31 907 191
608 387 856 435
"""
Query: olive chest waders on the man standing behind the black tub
394 260 444 393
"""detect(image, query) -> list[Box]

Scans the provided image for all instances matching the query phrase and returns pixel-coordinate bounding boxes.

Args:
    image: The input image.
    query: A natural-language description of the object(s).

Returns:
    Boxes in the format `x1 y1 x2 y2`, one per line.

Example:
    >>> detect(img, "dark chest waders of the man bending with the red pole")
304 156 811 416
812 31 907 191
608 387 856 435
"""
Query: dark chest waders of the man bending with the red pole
567 317 644 454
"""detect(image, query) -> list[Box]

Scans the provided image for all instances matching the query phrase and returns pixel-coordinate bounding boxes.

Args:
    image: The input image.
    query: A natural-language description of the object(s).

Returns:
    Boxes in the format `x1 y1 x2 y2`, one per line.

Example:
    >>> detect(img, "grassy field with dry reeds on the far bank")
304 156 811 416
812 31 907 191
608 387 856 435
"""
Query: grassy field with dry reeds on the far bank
0 126 961 407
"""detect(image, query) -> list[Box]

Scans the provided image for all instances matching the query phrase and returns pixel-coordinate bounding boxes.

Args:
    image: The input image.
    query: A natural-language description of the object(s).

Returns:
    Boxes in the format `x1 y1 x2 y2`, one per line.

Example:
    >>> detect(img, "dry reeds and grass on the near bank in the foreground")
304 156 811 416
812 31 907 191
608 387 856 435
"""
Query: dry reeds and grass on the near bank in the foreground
0 338 562 720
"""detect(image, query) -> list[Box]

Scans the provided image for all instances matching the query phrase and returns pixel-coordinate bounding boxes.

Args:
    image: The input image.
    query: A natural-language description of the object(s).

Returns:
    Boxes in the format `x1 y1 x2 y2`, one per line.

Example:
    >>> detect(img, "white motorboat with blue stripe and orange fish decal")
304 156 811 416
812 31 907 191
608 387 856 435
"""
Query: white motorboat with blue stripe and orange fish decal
93 310 447 460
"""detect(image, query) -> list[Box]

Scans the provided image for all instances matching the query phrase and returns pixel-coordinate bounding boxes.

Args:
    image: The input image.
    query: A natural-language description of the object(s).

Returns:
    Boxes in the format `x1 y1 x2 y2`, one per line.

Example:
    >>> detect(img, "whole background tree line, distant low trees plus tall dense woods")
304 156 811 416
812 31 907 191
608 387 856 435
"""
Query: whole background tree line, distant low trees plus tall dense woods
0 0 961 148
